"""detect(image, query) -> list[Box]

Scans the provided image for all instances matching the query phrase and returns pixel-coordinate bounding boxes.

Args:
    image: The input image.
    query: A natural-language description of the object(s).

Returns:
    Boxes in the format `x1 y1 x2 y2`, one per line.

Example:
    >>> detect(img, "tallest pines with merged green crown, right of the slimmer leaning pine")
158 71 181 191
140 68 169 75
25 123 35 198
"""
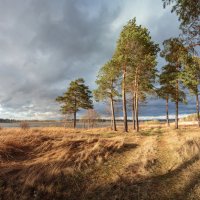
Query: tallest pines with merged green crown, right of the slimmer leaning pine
115 18 159 131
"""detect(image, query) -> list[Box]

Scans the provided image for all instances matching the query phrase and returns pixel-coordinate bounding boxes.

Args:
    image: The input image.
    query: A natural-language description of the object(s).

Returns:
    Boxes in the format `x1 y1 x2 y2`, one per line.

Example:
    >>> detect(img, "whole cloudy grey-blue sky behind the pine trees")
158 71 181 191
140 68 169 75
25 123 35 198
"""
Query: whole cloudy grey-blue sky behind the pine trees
0 0 197 119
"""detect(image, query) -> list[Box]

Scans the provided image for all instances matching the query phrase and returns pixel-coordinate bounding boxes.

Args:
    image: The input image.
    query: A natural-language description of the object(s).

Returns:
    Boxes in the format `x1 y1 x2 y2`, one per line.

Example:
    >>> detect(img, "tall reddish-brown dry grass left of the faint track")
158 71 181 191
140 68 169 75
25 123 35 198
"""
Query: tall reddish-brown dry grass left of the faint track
0 128 123 199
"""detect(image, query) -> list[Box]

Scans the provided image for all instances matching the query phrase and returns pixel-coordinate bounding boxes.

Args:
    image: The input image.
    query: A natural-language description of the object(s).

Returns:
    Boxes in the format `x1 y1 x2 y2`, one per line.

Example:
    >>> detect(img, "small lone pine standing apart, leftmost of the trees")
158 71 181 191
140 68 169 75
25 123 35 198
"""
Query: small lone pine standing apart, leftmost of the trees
56 78 93 128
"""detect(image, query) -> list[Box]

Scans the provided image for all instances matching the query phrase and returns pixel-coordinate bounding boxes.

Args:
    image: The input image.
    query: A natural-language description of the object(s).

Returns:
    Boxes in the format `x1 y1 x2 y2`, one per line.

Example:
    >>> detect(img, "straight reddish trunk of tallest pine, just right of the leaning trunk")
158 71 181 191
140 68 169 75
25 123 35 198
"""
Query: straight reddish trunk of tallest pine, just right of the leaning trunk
122 66 128 132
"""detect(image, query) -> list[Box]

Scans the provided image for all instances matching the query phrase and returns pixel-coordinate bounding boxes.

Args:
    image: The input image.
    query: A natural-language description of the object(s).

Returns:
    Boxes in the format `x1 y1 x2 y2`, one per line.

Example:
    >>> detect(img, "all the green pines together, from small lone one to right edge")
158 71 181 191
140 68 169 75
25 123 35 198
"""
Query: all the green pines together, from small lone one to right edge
56 0 200 132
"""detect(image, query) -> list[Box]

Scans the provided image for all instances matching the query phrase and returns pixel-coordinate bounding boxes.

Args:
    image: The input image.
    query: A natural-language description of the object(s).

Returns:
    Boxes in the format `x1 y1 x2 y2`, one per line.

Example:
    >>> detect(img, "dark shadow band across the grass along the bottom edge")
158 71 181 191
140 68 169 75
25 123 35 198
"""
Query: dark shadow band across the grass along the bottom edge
0 157 200 200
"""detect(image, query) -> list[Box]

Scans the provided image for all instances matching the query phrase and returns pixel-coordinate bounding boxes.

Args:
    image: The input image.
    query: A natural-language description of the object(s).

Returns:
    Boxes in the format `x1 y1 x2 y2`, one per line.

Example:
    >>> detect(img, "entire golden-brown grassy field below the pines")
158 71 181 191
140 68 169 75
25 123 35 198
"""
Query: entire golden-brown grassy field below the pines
0 126 200 200
